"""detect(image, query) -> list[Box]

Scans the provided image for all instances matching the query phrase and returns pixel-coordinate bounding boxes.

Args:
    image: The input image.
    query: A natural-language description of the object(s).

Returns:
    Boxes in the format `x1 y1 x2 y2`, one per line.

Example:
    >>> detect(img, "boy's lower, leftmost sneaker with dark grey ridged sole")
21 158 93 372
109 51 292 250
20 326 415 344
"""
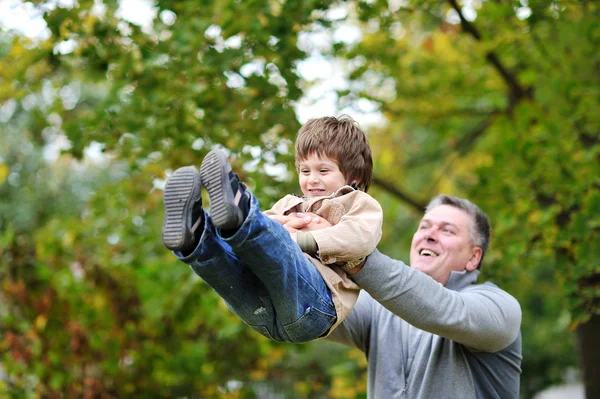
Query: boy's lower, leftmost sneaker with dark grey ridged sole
162 166 203 251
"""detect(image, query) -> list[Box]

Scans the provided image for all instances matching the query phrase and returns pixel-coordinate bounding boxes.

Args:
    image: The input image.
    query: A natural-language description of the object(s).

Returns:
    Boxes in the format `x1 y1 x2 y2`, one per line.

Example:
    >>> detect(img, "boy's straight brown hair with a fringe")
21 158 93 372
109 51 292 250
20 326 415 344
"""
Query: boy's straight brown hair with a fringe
296 115 373 192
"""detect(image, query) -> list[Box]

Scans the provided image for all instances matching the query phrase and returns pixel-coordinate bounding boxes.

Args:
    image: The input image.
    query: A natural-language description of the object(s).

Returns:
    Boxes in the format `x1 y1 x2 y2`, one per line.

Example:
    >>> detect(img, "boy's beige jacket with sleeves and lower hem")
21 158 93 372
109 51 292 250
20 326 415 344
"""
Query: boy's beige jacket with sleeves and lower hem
264 186 383 335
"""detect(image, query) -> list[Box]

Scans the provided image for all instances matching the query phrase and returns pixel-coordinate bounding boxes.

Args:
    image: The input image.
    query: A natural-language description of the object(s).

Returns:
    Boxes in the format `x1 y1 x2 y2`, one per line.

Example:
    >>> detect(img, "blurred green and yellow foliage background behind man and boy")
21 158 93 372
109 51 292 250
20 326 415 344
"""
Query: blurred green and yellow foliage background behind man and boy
0 0 600 398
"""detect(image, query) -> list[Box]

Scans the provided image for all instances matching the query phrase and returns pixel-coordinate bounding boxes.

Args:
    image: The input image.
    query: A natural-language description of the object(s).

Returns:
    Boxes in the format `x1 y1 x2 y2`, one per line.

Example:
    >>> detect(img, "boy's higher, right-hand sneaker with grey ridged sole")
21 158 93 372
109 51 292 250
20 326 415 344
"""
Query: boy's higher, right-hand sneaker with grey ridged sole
200 150 250 230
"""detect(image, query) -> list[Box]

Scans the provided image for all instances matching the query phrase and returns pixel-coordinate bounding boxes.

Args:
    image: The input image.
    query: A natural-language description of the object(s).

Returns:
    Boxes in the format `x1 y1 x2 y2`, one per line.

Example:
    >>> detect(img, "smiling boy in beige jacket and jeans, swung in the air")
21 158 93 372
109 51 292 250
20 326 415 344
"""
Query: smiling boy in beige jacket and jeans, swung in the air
162 116 383 342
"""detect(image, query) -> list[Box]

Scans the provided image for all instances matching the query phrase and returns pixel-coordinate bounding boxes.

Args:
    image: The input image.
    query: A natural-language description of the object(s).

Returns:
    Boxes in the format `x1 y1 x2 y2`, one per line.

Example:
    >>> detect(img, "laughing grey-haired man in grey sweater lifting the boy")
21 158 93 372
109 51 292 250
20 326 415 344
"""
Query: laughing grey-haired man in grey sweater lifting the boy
277 195 522 399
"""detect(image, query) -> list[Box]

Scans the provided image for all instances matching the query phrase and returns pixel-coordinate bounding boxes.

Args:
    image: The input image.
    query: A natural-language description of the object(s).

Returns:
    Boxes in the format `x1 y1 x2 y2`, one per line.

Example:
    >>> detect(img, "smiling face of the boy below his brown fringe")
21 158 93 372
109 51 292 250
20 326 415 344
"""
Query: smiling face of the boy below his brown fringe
298 154 348 197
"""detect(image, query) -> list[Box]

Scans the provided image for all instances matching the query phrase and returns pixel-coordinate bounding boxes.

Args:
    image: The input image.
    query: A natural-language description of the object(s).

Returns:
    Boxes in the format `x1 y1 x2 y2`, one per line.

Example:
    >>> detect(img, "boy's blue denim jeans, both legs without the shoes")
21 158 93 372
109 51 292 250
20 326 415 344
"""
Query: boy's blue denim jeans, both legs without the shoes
174 196 337 342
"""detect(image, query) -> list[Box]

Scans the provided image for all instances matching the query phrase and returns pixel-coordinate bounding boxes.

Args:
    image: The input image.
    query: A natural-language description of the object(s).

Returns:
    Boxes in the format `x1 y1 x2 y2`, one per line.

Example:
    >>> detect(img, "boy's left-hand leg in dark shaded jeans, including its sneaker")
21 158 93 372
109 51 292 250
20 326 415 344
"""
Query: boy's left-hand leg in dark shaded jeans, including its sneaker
162 166 274 338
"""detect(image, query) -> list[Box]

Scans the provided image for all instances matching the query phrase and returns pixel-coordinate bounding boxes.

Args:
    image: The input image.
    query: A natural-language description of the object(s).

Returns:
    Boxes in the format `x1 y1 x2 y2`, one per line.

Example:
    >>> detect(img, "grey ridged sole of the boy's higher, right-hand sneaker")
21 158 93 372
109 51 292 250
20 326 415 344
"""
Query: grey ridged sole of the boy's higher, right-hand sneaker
200 150 242 230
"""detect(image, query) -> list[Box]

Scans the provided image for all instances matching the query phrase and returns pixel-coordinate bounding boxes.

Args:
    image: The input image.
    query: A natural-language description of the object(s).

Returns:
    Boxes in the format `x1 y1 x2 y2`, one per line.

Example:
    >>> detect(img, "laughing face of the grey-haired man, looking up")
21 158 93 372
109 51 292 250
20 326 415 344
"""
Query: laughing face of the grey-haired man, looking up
410 205 482 285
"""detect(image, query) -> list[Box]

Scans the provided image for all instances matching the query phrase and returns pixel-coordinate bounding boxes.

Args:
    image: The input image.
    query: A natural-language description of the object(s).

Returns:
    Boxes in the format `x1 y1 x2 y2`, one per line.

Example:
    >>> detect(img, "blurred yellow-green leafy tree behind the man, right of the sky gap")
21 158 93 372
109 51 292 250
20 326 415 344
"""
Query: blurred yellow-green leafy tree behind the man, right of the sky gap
337 0 600 396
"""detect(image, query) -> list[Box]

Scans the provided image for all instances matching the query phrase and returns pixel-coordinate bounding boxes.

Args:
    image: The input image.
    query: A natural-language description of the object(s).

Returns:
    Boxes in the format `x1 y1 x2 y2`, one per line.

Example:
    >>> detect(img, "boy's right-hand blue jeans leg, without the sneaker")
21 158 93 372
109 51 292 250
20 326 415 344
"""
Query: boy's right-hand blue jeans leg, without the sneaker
223 197 337 342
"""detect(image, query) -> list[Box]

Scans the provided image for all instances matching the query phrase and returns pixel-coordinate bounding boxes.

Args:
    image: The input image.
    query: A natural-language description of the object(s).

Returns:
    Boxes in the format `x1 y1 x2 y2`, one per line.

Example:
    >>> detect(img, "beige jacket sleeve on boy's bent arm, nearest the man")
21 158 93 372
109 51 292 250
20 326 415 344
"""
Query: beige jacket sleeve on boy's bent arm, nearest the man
311 193 383 264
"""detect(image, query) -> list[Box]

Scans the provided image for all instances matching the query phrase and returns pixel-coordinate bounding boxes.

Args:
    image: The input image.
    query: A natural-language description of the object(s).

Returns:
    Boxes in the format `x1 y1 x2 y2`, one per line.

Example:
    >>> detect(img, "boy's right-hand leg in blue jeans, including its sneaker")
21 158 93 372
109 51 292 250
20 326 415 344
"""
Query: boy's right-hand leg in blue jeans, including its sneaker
200 150 336 342
